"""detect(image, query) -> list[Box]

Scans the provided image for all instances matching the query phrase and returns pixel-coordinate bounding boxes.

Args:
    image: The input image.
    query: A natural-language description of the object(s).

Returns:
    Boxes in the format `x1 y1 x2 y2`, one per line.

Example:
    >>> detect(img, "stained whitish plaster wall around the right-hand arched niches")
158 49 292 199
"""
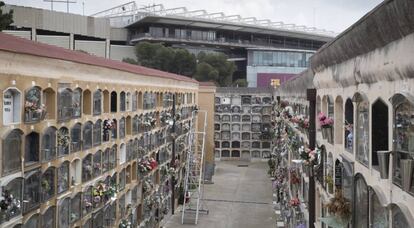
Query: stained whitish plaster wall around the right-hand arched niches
313 20 414 224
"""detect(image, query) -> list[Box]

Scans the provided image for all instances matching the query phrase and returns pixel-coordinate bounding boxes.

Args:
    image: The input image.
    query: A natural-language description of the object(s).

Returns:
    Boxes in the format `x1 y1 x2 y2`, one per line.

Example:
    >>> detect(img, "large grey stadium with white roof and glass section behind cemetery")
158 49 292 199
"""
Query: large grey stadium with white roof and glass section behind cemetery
4 2 335 87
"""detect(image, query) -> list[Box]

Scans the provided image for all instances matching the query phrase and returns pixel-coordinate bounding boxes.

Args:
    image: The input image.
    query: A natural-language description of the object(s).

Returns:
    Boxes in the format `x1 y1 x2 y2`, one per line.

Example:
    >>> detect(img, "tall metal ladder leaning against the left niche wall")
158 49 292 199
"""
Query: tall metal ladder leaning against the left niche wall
181 110 208 225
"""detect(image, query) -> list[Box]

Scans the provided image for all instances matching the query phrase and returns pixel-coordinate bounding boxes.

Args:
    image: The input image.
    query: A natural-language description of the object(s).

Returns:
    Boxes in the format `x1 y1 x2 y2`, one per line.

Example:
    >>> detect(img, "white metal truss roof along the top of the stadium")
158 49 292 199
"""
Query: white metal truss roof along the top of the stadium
91 1 336 42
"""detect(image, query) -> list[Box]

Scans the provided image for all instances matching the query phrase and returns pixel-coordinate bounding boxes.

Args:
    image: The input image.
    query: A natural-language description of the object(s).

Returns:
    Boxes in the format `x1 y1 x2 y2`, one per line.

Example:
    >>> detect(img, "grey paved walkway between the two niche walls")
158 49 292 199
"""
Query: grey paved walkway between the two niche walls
165 162 275 228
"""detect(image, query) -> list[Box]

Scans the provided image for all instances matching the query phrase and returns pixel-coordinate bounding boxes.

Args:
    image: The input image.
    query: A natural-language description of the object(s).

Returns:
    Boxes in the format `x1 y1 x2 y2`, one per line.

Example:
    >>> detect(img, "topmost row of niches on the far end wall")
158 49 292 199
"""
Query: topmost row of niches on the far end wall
214 95 272 105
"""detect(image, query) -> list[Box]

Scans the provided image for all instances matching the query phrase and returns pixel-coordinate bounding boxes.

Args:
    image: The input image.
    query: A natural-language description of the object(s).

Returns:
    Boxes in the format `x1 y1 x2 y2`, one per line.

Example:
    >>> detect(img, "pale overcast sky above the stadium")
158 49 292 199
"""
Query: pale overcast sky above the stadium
3 0 382 33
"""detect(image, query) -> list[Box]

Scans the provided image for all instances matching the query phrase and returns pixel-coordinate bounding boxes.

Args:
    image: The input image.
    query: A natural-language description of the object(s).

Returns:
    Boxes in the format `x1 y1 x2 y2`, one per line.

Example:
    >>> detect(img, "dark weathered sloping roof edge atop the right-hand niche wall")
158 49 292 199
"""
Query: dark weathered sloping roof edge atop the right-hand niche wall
311 0 414 72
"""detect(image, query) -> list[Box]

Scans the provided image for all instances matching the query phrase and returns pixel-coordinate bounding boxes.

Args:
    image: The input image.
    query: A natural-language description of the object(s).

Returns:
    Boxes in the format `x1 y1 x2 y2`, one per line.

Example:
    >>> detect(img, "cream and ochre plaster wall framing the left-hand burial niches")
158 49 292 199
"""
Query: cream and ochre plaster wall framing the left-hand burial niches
0 47 198 227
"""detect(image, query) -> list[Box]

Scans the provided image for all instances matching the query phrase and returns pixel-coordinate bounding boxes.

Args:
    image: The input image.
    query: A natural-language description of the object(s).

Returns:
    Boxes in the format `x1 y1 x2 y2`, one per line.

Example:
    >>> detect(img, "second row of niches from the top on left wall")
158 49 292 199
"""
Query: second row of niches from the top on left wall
2 118 189 176
